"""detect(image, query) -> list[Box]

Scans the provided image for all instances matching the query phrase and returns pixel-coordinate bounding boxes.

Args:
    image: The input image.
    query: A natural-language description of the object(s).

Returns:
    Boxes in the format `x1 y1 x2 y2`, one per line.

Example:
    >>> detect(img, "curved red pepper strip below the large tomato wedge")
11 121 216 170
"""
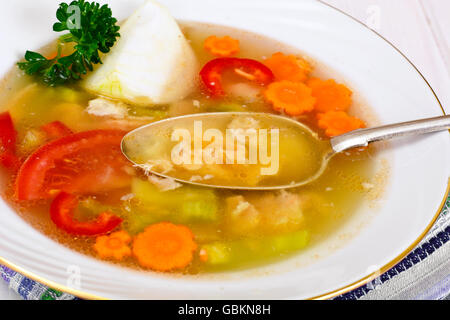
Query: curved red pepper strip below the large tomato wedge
50 192 123 236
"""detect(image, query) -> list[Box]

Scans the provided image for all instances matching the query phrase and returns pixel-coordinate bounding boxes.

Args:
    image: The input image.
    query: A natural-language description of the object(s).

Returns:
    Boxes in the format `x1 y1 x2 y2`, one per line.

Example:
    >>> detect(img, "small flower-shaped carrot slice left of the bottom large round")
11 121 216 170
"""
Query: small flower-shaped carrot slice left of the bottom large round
94 230 131 261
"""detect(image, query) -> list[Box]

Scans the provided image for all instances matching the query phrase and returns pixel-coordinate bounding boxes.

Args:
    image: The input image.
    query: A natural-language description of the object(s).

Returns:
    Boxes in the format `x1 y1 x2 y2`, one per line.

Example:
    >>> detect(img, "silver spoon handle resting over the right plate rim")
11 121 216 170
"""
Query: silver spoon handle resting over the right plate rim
330 116 450 153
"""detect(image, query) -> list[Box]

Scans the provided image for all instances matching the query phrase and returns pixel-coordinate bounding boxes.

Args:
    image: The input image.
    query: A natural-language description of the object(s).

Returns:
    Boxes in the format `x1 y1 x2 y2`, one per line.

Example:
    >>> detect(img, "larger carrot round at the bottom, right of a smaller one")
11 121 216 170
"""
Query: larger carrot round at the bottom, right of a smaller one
133 222 197 271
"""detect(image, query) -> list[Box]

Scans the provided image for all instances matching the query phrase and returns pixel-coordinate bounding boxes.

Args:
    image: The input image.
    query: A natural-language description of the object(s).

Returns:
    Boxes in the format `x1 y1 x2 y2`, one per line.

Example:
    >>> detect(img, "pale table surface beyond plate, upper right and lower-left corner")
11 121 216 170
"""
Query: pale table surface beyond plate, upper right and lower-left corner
0 0 450 300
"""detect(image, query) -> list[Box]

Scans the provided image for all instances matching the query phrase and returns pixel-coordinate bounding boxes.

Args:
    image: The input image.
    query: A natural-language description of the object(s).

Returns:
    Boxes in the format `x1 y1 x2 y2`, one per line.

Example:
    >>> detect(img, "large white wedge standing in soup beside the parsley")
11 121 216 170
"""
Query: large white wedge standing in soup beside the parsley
83 1 198 105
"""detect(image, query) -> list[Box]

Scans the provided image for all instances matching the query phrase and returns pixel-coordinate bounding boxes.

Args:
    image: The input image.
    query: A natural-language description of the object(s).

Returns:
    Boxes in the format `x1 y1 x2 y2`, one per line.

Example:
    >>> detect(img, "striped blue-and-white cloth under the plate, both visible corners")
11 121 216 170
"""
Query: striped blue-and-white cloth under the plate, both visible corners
0 197 450 300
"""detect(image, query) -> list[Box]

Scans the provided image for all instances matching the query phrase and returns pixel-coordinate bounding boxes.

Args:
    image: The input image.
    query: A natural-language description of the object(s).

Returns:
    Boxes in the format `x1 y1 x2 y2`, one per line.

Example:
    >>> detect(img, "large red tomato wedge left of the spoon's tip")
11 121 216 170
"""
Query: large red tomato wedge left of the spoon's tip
16 130 131 200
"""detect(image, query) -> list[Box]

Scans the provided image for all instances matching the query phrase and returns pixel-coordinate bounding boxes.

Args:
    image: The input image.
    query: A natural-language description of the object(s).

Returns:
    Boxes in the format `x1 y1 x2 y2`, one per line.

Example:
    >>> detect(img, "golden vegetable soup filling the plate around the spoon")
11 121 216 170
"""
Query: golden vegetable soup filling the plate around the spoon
1 15 386 274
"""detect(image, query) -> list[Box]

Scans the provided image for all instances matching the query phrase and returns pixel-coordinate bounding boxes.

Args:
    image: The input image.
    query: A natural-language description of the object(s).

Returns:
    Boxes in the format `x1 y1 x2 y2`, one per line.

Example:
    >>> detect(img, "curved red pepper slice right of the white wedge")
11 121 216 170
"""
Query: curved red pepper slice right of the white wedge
200 58 274 97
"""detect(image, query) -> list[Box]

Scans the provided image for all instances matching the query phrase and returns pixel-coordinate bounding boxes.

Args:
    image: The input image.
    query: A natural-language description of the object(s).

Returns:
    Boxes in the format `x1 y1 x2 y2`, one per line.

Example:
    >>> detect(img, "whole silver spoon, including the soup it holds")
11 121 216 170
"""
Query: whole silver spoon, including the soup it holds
122 112 450 190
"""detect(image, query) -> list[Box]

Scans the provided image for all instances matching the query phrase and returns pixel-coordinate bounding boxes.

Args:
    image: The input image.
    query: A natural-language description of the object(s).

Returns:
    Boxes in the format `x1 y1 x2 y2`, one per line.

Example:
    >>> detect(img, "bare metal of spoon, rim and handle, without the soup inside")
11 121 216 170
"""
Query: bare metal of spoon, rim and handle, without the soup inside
121 112 450 190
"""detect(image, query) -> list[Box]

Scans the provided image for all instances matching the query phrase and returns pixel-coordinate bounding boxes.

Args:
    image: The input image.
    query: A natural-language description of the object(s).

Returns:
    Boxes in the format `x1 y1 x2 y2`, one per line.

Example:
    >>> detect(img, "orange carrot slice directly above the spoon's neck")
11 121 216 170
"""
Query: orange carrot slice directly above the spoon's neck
317 111 366 137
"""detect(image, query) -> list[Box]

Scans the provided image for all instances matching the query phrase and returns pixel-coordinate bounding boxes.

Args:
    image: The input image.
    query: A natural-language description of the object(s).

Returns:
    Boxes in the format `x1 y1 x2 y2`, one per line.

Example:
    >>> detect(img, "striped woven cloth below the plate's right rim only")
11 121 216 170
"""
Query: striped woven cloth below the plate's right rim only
335 196 450 300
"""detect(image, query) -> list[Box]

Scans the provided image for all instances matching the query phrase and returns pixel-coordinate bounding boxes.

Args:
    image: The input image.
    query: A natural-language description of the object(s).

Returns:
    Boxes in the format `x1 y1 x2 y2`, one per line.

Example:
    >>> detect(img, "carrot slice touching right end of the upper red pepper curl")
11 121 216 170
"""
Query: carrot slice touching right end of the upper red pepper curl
264 52 312 82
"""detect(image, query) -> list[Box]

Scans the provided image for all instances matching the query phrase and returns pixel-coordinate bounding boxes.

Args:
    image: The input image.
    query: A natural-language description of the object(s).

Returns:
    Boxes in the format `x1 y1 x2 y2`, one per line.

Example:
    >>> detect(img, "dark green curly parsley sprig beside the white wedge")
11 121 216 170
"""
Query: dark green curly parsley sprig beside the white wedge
18 0 120 86
